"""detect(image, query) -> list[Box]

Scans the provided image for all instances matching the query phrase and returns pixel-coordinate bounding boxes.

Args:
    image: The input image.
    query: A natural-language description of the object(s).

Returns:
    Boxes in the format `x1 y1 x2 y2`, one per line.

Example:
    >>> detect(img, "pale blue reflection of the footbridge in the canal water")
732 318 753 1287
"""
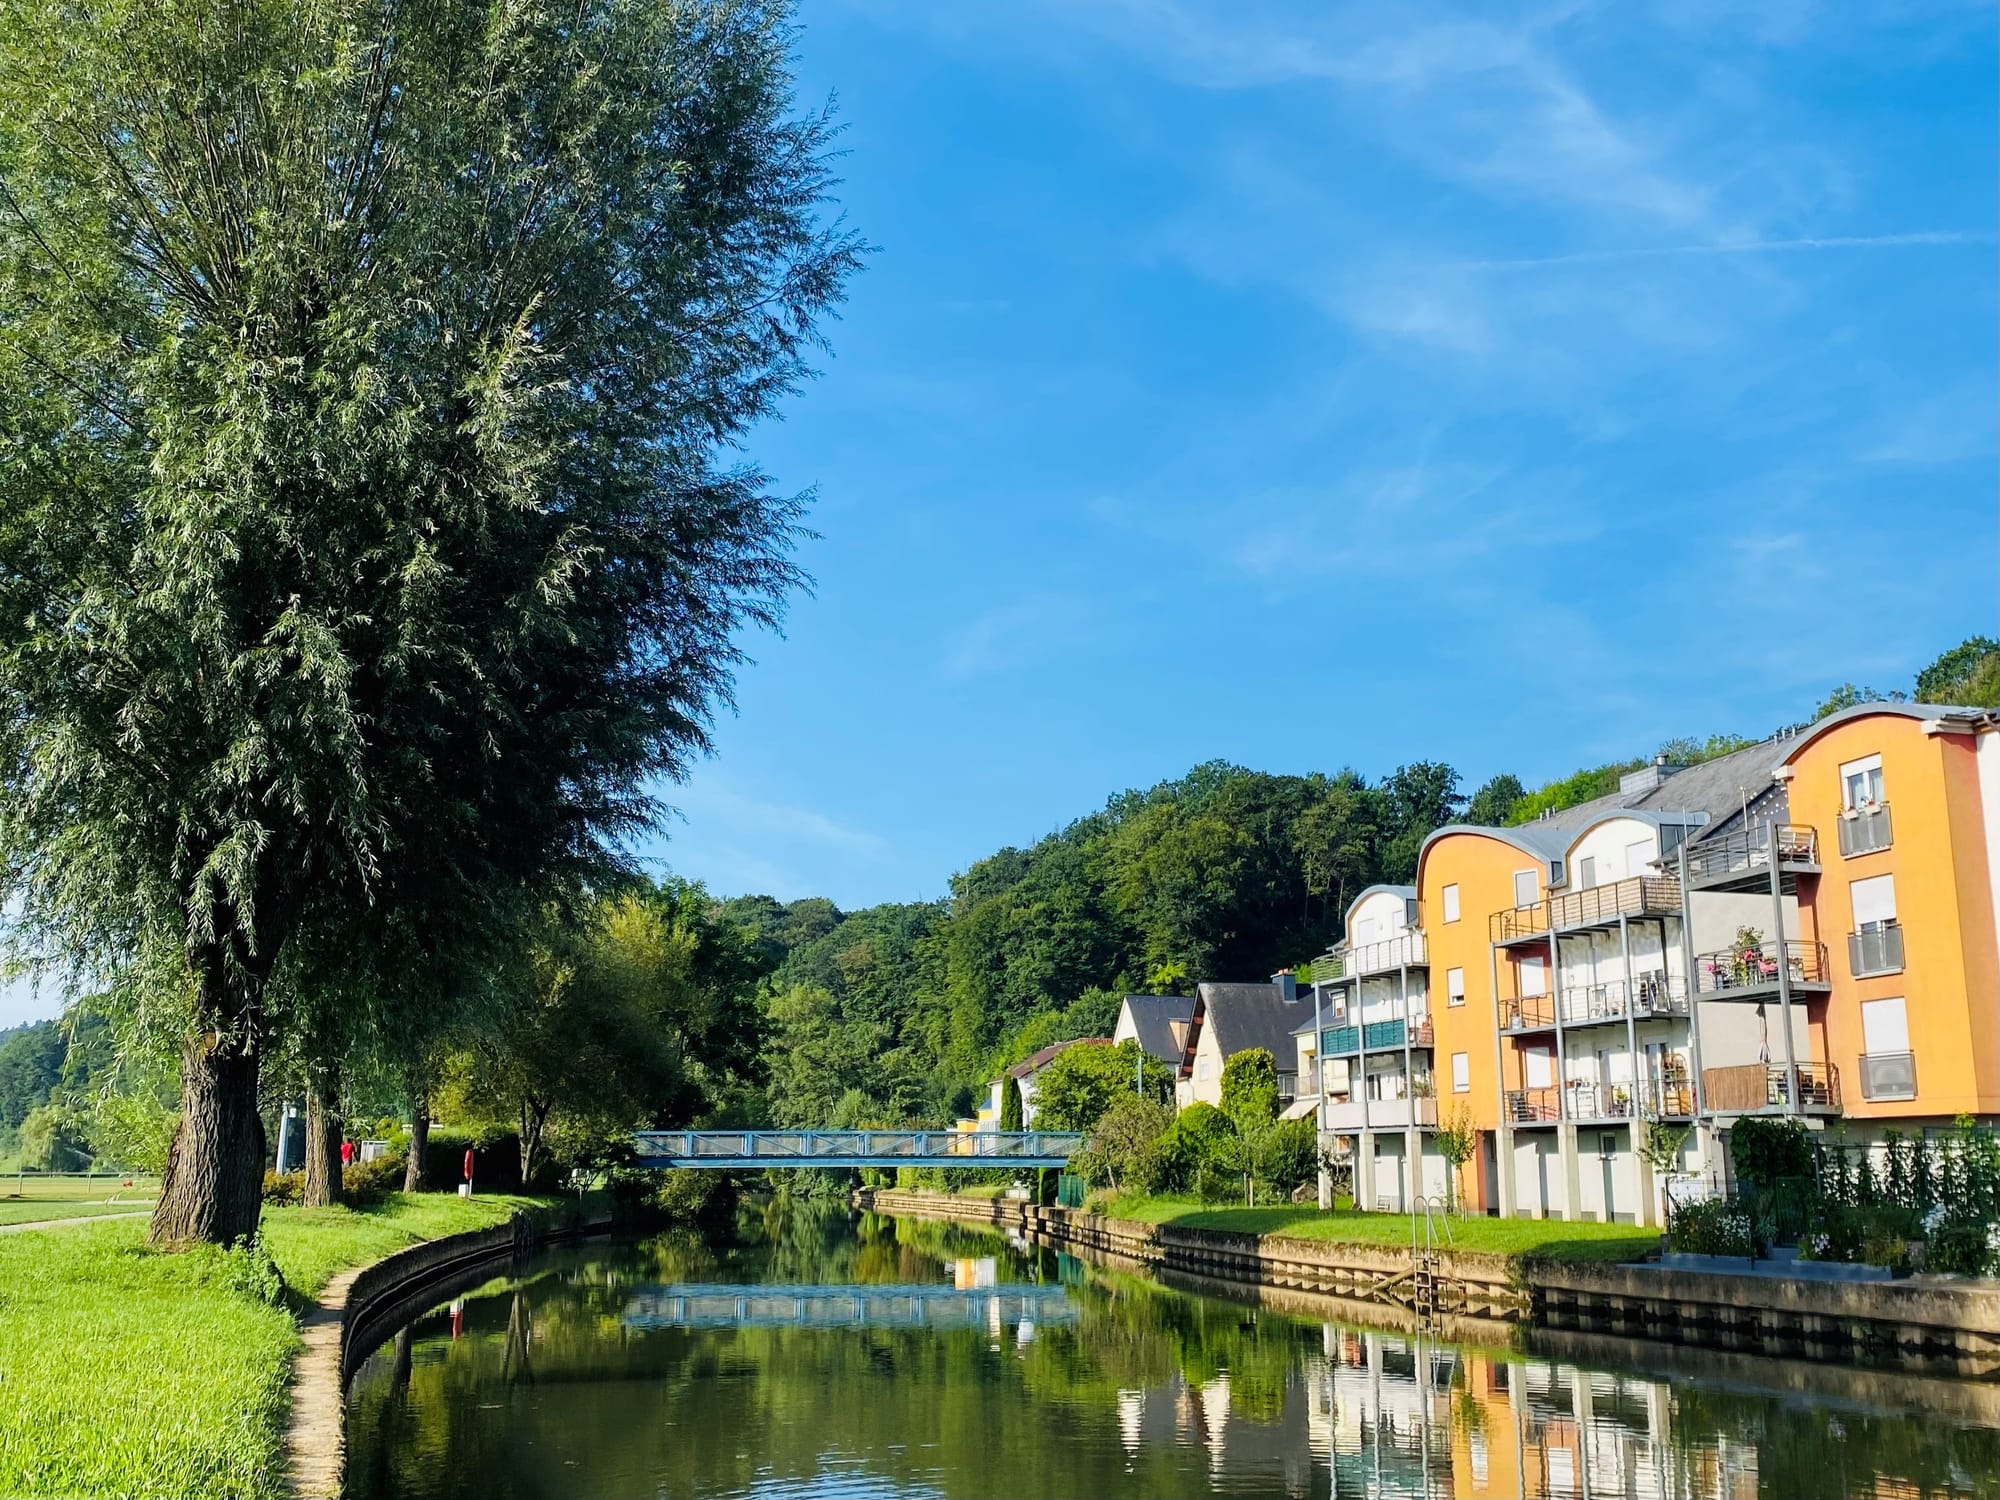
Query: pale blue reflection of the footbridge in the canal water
624 1282 1076 1328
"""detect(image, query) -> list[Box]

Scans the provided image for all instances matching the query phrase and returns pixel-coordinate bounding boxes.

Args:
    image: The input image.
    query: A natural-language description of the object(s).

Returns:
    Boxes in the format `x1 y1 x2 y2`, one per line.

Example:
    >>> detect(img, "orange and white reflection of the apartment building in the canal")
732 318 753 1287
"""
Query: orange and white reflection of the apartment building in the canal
1314 1326 1758 1500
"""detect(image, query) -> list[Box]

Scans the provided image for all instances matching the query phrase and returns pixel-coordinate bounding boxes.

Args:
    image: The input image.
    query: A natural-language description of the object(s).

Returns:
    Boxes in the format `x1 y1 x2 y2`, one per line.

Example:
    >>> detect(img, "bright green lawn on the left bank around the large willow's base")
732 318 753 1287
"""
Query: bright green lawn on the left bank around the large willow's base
0 1194 540 1496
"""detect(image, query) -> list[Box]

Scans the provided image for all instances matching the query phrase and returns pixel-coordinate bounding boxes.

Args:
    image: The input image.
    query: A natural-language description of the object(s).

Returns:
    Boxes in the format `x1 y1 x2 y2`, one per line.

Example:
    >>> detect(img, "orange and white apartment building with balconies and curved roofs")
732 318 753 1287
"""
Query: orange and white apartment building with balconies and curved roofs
1298 704 2000 1224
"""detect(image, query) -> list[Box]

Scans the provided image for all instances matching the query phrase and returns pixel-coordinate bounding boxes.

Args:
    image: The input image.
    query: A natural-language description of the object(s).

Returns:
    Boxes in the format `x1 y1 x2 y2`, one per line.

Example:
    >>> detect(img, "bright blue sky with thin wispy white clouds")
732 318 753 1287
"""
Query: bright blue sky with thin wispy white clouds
8 0 2000 1012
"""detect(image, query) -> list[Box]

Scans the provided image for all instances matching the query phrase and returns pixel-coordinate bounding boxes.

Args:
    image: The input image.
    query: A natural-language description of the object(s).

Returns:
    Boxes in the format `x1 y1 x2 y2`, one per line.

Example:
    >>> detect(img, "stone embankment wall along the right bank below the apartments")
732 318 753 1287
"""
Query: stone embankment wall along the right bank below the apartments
856 1188 2000 1378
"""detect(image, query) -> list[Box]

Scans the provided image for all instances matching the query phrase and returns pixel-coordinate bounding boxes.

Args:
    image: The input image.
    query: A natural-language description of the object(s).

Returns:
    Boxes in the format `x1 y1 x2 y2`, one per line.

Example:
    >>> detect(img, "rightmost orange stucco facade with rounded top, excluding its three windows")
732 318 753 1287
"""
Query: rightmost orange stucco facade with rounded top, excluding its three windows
1780 708 2000 1120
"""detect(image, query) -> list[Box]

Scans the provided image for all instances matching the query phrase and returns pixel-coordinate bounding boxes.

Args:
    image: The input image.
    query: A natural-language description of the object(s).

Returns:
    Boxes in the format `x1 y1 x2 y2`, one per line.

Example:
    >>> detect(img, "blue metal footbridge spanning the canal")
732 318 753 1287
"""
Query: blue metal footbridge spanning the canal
634 1130 1084 1168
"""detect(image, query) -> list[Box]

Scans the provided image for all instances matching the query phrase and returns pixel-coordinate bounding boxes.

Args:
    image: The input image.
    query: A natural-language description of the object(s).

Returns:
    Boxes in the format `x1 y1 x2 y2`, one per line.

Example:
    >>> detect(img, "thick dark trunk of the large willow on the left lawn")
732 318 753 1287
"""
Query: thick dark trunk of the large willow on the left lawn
146 1028 264 1246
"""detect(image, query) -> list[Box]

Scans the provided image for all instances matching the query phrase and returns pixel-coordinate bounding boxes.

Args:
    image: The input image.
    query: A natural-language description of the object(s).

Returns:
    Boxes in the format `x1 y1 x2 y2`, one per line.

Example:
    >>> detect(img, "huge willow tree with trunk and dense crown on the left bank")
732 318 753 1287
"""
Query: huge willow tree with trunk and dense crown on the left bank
0 0 858 1242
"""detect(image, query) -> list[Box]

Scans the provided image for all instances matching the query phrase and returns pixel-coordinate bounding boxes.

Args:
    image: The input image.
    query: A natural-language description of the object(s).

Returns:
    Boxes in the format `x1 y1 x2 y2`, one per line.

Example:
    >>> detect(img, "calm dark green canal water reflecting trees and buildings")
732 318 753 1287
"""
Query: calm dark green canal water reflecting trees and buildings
348 1202 2000 1500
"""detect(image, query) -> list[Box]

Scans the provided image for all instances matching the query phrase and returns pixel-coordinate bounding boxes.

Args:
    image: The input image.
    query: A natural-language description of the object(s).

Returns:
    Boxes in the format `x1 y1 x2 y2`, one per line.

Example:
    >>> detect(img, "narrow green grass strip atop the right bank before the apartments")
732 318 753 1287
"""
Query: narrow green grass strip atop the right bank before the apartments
1102 1194 1660 1260
